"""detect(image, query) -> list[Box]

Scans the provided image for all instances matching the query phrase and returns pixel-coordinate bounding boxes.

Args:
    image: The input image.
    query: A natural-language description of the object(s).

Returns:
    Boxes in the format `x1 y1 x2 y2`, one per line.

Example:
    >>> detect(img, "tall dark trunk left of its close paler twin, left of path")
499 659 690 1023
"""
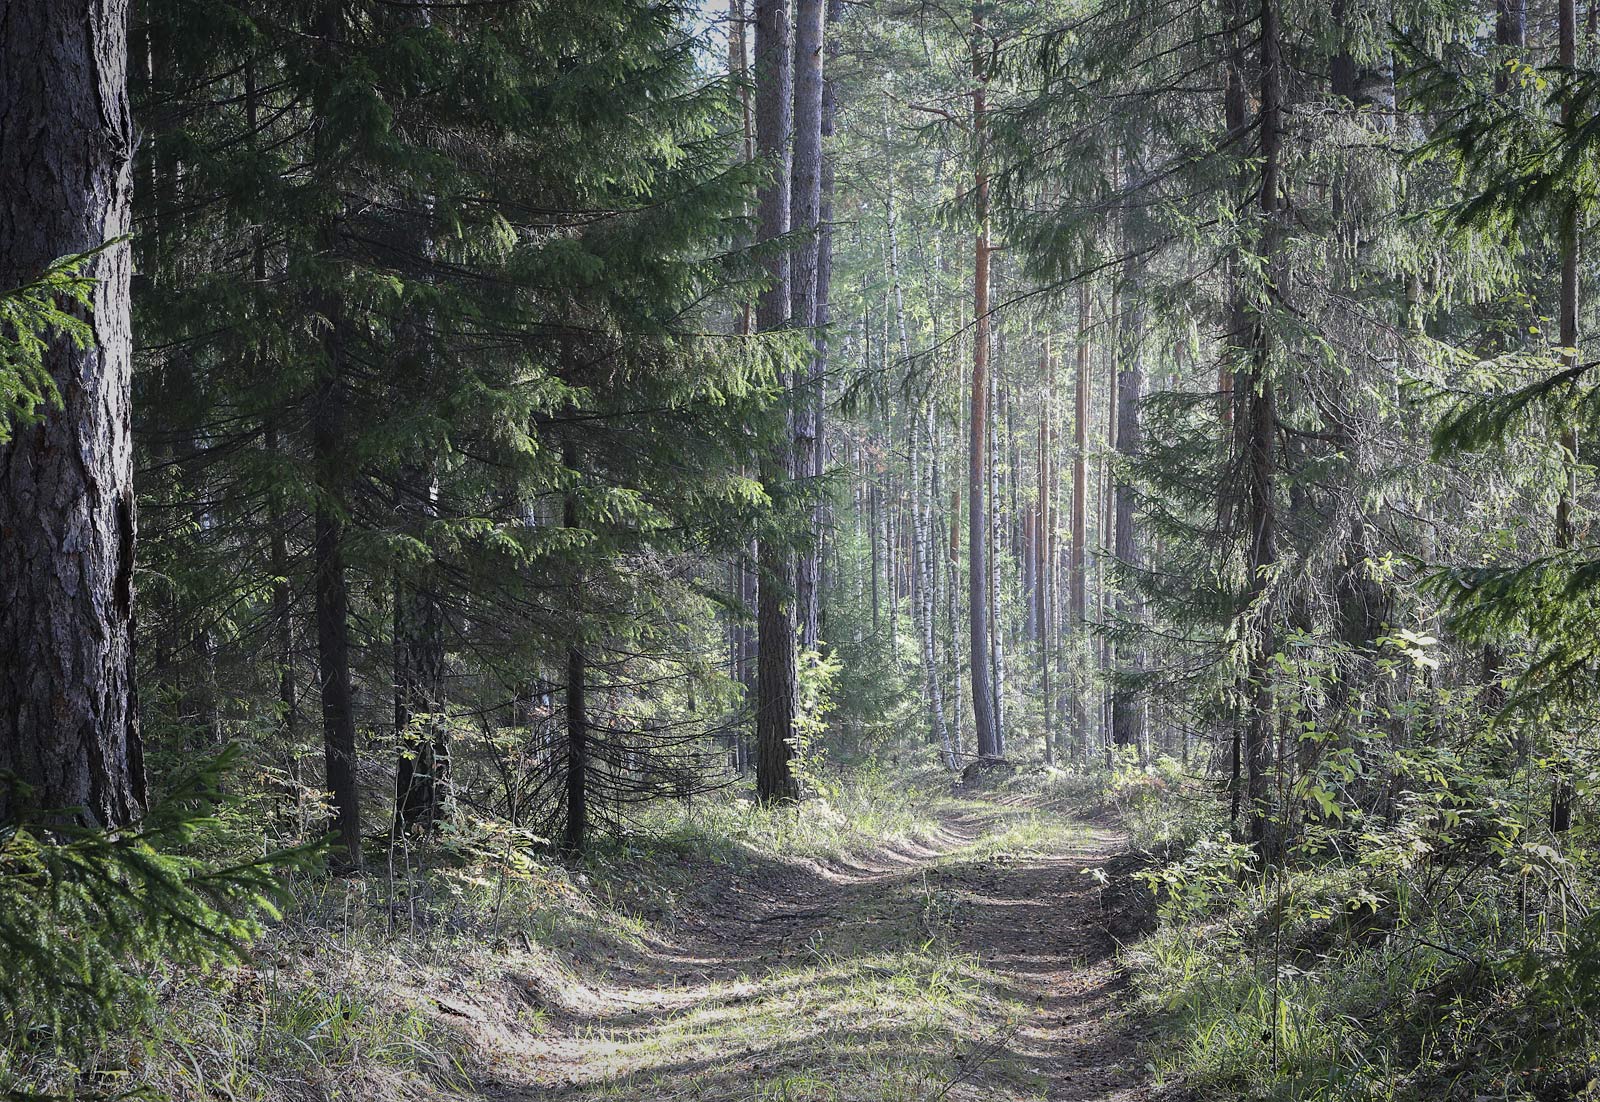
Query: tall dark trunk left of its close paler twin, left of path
755 0 800 803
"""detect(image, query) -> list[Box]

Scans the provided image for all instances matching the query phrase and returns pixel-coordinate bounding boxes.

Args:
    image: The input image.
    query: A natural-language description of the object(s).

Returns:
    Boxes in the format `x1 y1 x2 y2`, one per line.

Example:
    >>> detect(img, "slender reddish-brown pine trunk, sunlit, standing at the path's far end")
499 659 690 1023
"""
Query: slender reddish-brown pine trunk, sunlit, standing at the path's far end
966 8 1000 758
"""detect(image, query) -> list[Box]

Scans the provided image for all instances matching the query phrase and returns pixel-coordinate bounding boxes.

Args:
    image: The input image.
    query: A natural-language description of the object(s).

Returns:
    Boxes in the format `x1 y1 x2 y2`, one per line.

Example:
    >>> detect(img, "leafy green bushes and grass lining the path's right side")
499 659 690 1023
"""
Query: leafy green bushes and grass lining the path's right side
1130 630 1600 1102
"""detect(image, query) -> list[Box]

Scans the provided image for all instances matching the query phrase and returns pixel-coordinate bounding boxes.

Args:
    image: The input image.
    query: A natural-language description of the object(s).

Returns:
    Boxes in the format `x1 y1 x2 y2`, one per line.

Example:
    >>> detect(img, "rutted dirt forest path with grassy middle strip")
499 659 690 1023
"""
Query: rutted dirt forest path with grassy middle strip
483 801 1147 1102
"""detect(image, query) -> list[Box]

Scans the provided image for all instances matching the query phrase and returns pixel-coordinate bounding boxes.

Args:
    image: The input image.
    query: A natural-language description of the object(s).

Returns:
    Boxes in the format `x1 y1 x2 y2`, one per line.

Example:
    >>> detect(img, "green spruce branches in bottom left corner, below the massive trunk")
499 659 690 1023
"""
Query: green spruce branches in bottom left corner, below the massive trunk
0 750 315 1096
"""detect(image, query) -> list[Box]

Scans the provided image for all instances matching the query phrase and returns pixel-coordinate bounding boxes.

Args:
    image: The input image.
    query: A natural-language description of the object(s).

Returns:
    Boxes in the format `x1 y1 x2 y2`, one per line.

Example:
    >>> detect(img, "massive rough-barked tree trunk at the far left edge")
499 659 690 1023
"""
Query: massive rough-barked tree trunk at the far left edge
0 0 146 825
